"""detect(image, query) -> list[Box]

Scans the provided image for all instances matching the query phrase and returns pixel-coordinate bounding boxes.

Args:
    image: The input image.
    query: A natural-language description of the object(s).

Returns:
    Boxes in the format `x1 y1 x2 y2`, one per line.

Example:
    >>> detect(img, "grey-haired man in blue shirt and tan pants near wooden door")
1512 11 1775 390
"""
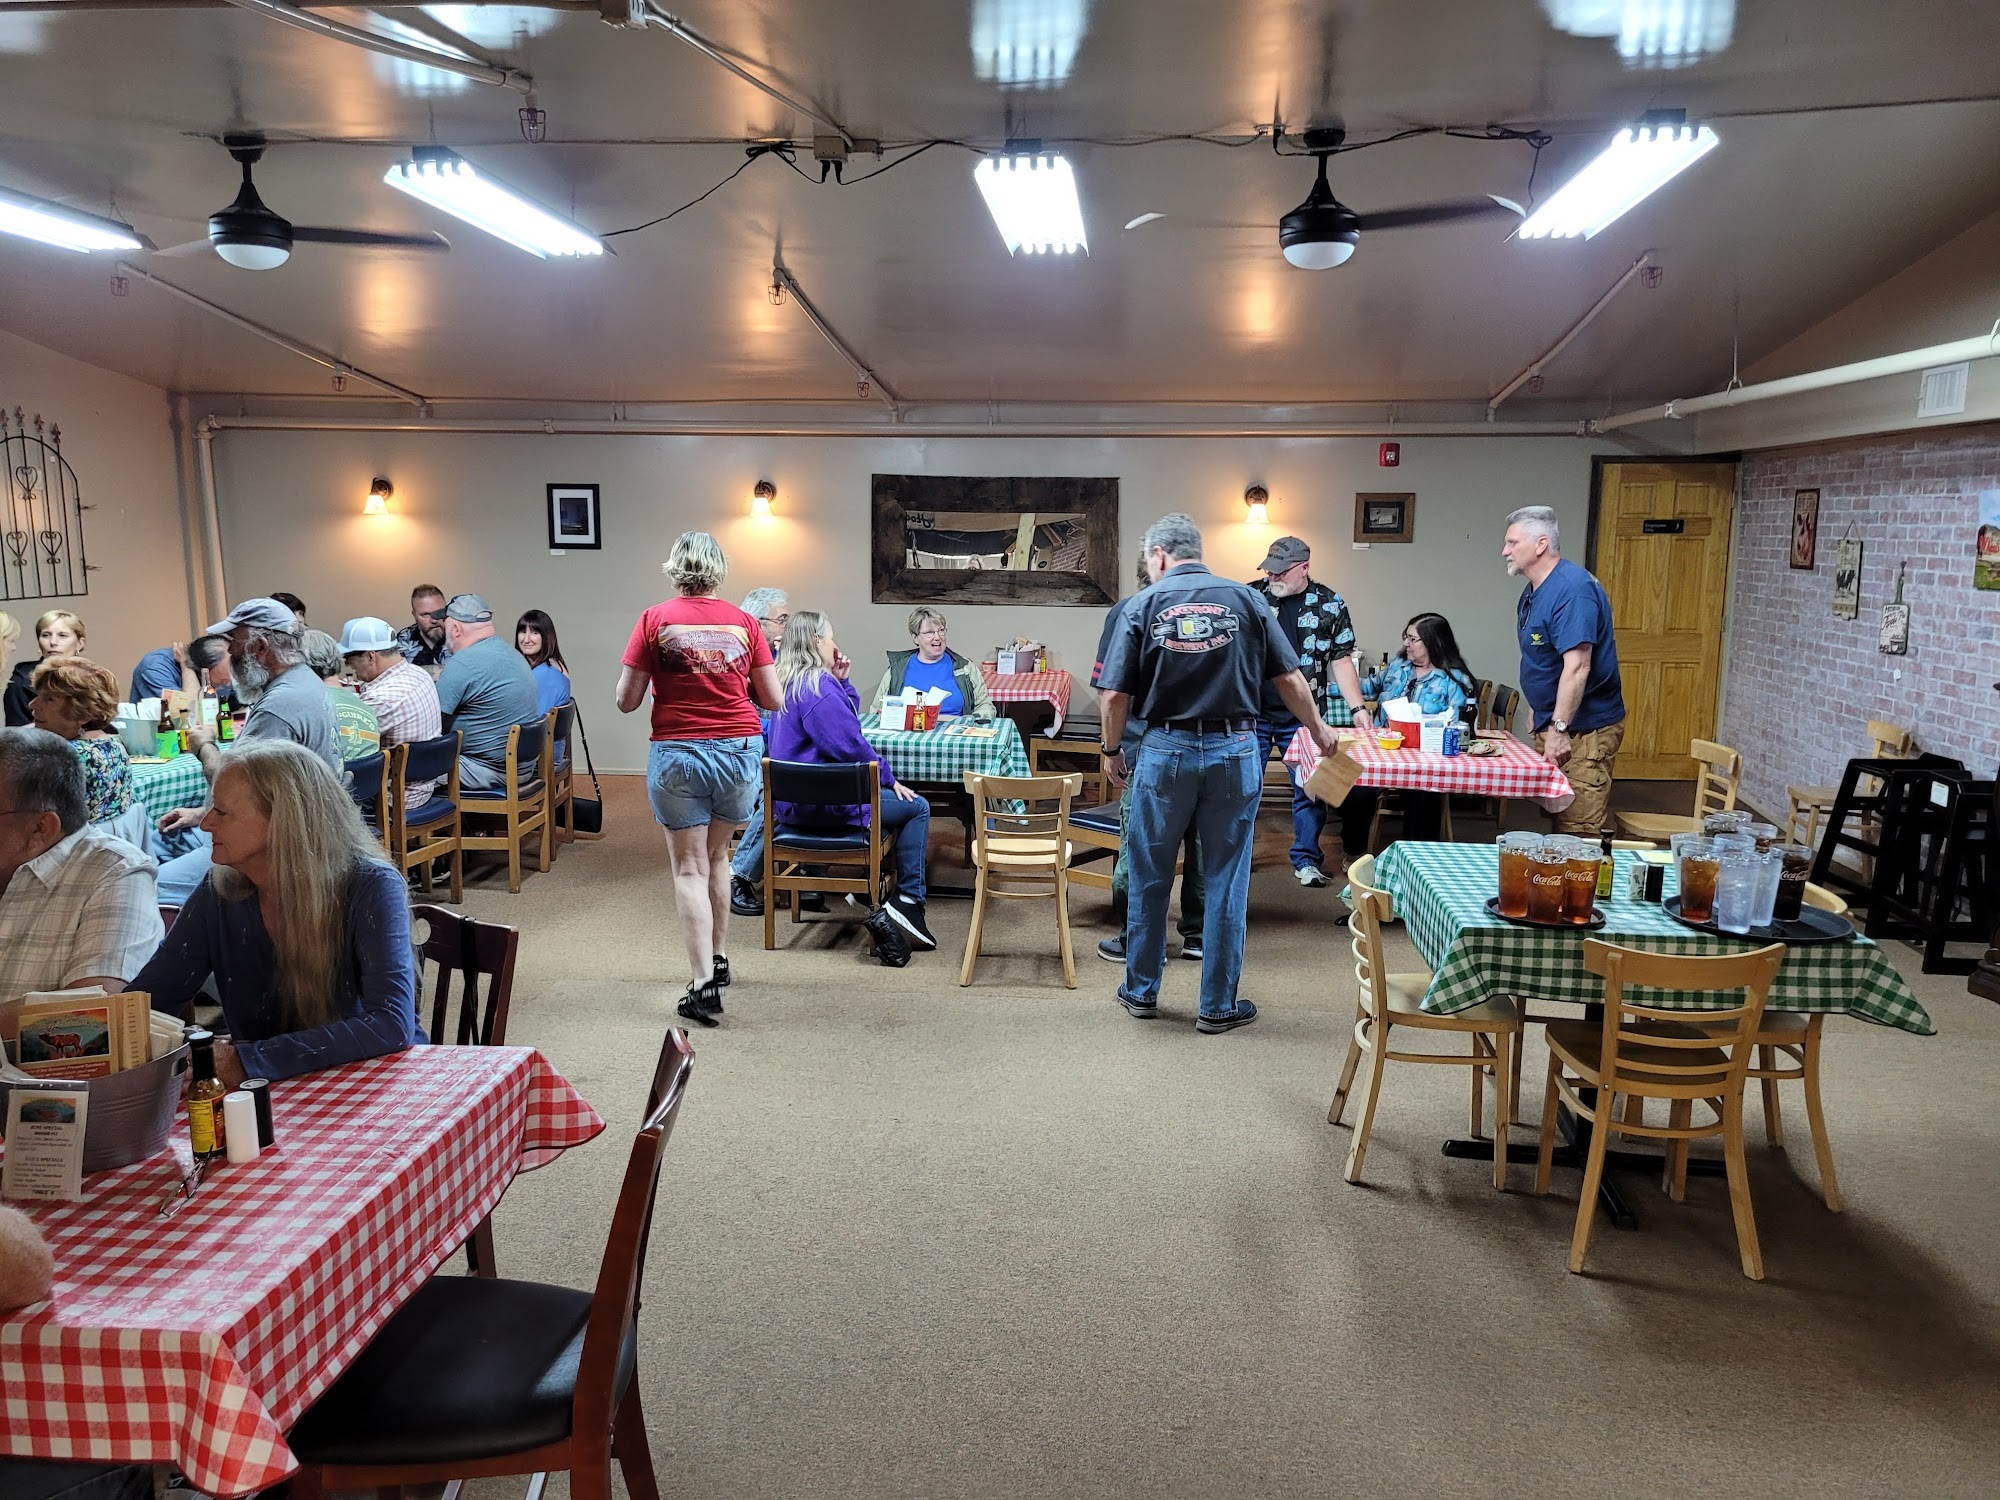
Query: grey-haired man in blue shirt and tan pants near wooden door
1500 506 1624 838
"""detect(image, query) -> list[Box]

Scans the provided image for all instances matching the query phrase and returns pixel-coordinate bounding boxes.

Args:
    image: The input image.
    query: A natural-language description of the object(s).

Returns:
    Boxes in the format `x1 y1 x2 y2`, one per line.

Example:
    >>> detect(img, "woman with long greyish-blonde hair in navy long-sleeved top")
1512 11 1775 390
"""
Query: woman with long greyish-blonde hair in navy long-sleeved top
132 740 424 1084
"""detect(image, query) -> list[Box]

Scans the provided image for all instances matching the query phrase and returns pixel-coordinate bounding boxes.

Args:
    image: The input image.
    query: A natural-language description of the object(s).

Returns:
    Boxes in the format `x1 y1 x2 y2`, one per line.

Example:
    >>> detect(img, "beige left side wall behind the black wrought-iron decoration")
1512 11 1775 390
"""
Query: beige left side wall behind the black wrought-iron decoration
0 332 206 686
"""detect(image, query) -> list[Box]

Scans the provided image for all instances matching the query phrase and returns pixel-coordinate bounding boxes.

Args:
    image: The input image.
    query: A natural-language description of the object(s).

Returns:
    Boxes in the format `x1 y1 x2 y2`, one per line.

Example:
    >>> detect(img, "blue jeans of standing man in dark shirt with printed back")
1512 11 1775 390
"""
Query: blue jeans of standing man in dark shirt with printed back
1118 728 1264 1020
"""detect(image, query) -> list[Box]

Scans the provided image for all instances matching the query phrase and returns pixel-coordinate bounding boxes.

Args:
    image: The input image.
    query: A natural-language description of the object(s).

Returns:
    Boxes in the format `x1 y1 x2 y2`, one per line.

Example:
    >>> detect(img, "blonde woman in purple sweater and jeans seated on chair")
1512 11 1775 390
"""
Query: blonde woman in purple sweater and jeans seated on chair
768 610 938 948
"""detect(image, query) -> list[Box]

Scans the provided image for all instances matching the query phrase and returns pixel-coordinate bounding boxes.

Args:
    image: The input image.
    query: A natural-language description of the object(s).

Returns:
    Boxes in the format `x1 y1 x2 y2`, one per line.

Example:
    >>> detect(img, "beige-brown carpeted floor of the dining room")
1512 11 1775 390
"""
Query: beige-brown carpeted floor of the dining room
454 778 2000 1500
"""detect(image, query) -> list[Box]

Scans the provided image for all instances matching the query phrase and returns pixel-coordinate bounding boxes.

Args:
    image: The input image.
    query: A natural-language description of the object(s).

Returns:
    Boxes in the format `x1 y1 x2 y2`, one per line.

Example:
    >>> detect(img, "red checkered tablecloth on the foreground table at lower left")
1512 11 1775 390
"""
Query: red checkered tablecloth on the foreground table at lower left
0 1046 604 1496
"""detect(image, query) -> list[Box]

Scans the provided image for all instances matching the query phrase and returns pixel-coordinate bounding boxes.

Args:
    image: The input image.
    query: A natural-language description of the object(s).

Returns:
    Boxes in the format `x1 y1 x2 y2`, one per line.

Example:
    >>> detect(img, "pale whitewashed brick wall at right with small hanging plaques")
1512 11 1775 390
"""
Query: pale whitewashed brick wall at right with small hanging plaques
1722 430 2000 814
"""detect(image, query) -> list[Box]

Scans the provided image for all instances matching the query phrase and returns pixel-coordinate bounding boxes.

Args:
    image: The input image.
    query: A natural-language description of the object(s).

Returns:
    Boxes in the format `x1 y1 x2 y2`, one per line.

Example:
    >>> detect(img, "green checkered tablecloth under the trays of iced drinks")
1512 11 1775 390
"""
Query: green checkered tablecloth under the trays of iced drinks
1376 842 1936 1036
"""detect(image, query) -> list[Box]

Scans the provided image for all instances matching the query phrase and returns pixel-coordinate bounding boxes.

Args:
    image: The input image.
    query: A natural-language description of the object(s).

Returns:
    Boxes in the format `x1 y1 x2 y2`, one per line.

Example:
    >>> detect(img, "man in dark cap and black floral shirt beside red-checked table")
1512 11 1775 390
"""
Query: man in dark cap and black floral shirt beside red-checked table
1250 536 1376 886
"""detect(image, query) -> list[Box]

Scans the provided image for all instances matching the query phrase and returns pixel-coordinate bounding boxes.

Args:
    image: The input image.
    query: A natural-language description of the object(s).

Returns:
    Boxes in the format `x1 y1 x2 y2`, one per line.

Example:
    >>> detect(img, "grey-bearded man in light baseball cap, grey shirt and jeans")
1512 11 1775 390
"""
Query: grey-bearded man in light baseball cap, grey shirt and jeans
154 598 340 906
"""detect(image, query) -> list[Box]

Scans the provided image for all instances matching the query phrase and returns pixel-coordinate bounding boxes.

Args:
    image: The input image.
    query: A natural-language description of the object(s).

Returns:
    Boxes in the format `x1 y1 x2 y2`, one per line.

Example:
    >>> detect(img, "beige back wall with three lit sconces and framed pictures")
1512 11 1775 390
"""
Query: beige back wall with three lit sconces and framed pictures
216 432 1592 770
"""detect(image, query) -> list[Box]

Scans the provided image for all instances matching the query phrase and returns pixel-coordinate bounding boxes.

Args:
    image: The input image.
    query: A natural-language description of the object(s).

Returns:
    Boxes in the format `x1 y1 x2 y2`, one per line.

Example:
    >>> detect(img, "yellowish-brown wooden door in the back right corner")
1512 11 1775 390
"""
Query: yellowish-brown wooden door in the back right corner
1590 464 1736 782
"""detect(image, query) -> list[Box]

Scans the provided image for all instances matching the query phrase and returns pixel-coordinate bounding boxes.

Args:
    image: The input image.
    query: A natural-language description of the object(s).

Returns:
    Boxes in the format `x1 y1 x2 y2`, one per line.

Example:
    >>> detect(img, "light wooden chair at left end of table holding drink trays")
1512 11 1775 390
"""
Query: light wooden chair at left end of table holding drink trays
1326 854 1522 1188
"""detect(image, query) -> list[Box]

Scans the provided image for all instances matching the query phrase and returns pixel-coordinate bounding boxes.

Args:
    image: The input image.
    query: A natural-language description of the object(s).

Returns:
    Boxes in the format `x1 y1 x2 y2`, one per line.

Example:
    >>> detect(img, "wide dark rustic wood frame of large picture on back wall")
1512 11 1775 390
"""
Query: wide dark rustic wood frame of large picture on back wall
868 474 1126 608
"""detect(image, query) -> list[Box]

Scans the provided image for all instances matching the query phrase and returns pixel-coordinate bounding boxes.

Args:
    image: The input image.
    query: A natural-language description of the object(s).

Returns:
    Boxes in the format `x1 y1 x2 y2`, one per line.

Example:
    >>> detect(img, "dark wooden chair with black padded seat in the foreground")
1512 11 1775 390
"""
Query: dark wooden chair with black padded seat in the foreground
288 1026 694 1500
